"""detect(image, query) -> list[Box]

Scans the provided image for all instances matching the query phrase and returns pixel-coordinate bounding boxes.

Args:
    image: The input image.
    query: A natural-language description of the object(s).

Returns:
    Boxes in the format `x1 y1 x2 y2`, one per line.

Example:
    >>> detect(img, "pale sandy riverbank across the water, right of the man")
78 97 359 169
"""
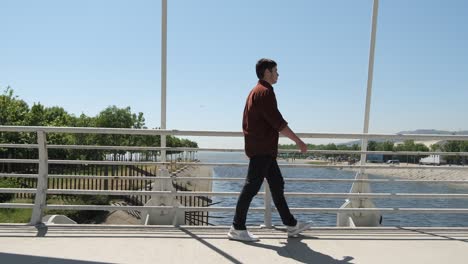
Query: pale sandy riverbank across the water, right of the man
289 159 468 181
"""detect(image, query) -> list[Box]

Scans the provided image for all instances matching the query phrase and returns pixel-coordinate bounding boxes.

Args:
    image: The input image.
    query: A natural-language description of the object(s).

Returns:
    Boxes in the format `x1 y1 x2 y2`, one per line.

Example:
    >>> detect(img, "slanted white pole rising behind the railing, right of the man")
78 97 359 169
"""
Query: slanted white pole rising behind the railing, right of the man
361 0 379 169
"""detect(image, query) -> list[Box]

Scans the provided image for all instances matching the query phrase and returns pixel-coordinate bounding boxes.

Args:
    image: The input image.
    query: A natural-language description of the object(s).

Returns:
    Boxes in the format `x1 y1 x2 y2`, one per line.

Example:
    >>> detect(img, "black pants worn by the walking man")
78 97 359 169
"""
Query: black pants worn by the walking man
232 156 297 230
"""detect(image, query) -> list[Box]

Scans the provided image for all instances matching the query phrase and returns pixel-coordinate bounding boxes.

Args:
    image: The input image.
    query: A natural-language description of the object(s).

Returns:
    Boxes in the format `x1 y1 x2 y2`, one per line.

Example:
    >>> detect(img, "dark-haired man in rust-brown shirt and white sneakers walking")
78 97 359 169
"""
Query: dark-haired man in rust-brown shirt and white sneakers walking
228 59 312 241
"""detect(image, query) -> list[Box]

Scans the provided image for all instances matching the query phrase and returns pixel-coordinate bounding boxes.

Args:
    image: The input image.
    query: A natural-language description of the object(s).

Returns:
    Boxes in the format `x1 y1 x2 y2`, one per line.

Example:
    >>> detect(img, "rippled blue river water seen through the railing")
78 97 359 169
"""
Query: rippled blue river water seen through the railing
197 152 468 227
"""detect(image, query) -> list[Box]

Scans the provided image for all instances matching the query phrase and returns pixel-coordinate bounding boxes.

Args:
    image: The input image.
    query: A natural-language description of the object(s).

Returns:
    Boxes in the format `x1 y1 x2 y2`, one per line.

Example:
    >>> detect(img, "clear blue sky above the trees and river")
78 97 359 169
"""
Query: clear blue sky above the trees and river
0 0 468 147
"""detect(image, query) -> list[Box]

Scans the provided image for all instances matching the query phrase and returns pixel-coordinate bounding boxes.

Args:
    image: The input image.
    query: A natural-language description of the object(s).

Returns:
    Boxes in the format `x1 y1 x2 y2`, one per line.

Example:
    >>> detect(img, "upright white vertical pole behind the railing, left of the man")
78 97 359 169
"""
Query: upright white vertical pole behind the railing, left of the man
161 0 167 162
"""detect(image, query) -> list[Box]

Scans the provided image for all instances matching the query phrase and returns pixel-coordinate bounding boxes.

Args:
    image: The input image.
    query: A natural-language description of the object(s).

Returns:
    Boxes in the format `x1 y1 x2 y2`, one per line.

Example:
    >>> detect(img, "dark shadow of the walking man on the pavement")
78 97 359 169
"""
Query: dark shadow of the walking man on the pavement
245 235 354 264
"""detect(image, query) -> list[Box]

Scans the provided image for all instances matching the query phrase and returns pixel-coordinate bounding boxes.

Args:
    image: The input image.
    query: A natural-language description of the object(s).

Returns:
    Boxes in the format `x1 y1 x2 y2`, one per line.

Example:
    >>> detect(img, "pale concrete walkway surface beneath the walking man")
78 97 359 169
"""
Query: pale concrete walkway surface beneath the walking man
0 224 468 264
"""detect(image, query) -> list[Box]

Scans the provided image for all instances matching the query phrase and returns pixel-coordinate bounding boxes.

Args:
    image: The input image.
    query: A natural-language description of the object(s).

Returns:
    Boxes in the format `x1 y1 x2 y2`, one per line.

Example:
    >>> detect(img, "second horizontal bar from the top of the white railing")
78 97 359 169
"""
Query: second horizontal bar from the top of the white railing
0 144 468 156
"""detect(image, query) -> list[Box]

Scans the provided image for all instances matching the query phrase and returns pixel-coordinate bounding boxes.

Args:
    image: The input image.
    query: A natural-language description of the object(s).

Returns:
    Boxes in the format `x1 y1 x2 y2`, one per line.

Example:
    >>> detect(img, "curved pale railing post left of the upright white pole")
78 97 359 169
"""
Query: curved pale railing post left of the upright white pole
30 131 49 225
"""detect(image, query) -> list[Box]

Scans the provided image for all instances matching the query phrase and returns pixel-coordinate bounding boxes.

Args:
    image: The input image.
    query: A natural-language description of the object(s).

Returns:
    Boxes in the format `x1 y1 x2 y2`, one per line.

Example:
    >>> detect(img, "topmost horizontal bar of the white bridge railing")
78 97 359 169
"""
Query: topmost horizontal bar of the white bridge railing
0 126 468 140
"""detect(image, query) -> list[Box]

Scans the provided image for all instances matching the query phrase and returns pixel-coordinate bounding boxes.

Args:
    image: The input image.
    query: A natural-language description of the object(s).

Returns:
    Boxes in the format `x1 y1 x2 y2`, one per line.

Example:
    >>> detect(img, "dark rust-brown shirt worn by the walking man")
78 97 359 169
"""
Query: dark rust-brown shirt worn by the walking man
242 80 288 158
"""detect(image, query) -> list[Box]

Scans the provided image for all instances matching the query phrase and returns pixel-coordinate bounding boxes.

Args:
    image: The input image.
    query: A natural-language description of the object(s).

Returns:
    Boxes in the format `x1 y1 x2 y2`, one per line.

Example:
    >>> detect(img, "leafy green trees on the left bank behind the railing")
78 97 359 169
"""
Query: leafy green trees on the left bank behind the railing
0 87 198 160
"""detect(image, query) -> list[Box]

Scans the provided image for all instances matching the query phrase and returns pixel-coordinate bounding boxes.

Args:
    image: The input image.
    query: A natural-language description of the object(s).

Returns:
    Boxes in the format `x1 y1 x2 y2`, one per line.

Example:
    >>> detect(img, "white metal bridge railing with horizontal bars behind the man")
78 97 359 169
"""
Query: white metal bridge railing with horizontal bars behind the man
0 126 468 227
